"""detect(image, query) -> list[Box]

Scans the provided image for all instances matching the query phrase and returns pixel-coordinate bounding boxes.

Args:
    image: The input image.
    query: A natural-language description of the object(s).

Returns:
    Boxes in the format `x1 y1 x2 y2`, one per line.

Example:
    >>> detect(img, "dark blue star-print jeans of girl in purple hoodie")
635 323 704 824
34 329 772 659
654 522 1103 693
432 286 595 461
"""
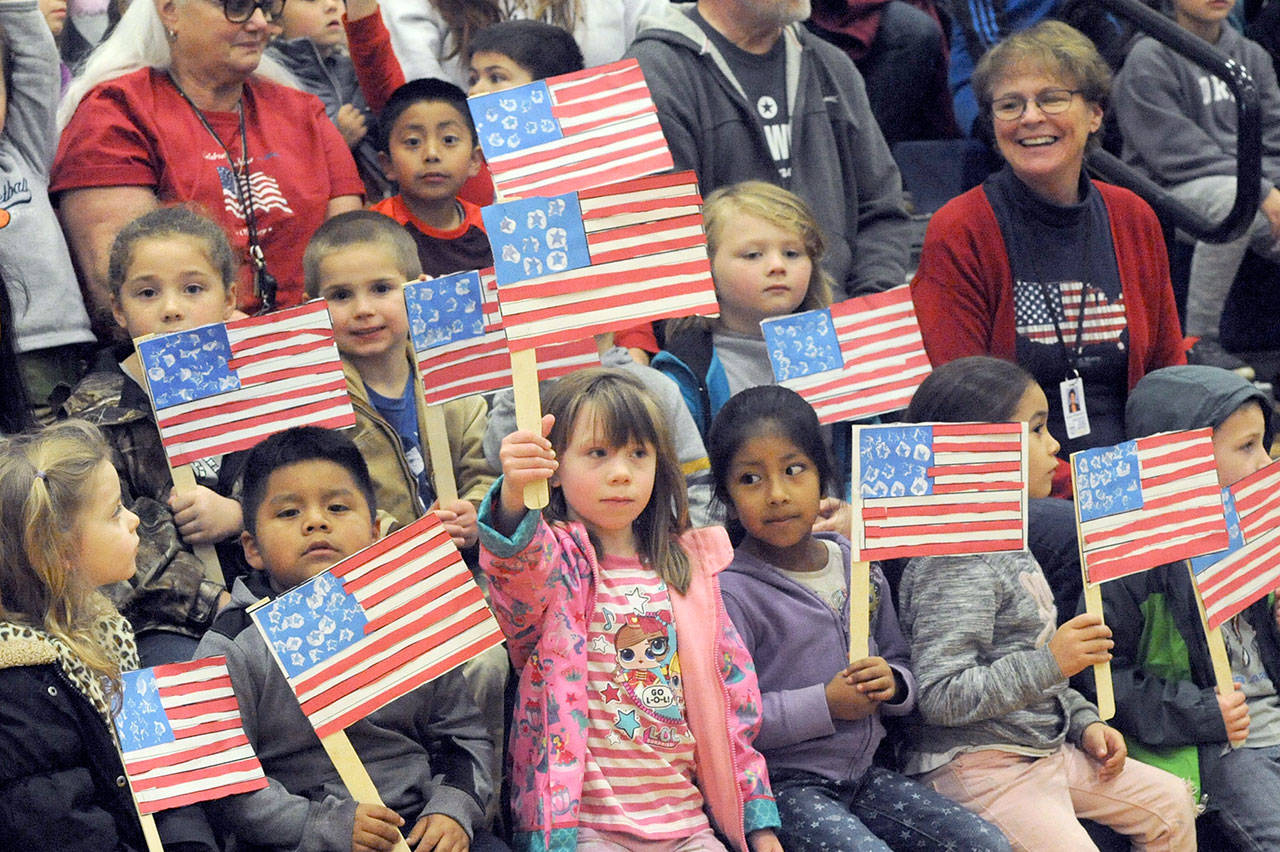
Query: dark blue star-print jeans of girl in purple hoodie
771 766 1010 852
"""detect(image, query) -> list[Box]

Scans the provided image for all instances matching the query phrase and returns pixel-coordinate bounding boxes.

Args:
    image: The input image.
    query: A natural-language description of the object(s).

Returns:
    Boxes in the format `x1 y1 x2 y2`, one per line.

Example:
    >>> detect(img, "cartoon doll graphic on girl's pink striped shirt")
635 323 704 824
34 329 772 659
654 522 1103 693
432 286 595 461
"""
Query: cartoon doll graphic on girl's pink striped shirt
613 613 684 723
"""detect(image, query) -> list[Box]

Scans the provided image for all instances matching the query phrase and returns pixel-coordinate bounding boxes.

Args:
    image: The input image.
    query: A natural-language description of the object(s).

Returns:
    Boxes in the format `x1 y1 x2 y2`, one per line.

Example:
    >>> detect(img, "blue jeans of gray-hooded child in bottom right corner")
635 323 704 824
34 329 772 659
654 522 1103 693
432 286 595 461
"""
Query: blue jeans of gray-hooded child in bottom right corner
1201 746 1280 852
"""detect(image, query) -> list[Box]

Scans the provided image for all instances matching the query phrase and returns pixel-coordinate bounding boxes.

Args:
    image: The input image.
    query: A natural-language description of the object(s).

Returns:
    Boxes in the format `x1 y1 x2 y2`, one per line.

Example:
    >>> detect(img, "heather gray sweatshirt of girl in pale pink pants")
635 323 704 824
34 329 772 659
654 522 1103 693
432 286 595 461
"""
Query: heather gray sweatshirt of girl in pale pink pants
899 550 1100 774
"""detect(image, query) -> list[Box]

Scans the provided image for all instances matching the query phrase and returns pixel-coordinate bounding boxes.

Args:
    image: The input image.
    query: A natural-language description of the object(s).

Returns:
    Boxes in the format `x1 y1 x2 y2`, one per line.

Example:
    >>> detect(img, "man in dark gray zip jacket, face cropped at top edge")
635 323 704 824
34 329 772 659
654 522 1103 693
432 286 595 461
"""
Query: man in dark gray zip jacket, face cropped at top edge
627 0 909 296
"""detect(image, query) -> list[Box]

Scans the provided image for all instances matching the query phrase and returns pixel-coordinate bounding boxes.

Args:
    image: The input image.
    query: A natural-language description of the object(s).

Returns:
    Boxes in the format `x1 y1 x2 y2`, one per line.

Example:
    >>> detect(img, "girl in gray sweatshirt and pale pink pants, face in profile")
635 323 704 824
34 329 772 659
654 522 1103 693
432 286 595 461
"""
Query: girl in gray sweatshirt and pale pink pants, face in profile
899 356 1196 849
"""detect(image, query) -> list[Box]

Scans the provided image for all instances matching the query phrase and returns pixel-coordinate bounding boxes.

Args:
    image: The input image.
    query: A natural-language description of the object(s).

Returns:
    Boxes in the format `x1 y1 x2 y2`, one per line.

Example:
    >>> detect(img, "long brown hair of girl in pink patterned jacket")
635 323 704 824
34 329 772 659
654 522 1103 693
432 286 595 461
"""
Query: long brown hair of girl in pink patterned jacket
543 367 690 594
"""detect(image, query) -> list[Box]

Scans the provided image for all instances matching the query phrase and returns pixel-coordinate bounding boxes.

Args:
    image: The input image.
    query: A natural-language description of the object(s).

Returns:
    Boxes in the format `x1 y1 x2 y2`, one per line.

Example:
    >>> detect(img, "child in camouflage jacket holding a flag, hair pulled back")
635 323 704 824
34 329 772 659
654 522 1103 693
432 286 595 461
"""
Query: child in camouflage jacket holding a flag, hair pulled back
63 206 243 665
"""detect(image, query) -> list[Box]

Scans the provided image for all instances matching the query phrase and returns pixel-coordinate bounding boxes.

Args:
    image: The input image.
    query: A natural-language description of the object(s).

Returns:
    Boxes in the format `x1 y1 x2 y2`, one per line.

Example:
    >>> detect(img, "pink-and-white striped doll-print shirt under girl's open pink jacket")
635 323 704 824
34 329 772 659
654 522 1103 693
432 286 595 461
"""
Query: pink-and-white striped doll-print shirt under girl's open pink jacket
581 556 709 838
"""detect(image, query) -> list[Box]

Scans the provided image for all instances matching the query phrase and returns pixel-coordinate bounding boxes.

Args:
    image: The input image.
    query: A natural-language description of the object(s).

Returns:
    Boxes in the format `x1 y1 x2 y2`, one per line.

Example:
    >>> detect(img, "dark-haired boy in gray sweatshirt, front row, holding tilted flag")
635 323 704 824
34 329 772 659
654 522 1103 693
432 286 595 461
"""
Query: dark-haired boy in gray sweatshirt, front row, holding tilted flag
197 426 506 852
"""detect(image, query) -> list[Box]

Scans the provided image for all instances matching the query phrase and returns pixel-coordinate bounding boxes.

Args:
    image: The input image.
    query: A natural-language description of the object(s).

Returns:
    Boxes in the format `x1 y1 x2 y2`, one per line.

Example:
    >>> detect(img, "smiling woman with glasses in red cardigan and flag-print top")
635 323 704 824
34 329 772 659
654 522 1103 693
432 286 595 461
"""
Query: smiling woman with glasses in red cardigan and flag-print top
911 20 1184 494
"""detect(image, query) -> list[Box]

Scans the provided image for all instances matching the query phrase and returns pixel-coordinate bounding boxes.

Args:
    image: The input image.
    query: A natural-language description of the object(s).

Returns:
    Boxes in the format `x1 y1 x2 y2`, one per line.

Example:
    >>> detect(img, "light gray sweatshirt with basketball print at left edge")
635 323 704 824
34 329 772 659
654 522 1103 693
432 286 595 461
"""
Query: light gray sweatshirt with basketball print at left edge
0 0 93 352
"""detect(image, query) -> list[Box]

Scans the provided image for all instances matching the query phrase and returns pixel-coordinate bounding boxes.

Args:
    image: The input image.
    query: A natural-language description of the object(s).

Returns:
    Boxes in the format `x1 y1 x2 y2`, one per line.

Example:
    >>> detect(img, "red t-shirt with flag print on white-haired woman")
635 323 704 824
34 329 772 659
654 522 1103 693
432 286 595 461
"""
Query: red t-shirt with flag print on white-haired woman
49 68 364 313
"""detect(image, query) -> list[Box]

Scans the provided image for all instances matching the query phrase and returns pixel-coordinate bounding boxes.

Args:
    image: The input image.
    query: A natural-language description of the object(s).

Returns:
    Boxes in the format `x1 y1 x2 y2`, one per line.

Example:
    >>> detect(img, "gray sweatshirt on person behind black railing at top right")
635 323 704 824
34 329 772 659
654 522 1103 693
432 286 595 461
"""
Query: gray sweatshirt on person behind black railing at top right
1112 26 1280 196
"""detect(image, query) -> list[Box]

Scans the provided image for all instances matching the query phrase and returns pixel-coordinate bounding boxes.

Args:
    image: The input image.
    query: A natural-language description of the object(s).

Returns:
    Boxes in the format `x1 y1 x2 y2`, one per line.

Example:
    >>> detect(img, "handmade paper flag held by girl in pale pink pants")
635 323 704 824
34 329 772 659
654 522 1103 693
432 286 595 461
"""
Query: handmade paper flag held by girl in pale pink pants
1071 429 1228 583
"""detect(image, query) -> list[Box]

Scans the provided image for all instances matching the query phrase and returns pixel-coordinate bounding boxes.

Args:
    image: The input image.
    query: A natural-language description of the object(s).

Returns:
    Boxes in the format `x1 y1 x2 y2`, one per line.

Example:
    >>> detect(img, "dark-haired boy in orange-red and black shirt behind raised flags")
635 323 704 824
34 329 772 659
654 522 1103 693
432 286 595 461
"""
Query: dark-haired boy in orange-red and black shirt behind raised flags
372 79 493 276
